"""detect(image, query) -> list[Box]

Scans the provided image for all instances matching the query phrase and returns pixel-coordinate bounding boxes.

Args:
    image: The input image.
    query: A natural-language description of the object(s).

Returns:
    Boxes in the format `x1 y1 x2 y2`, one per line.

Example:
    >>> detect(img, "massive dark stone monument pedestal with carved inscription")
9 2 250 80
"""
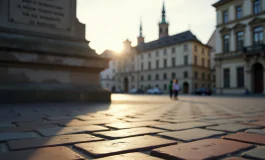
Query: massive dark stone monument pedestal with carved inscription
0 0 110 103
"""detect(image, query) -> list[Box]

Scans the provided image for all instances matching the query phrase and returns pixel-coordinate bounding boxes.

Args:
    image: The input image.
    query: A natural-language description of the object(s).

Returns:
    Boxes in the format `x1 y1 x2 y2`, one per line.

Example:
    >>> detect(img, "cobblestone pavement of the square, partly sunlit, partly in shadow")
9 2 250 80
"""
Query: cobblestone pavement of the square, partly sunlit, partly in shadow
0 95 265 160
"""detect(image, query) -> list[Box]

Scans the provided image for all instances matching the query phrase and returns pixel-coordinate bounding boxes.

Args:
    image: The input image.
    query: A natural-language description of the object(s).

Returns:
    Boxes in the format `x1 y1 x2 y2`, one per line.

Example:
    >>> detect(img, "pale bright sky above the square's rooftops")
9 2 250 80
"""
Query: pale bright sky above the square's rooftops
77 0 217 54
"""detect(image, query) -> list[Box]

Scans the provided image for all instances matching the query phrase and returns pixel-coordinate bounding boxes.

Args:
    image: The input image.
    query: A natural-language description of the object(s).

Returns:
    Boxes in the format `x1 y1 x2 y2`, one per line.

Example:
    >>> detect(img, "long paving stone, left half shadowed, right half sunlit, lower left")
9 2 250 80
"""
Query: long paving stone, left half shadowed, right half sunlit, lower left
7 134 102 151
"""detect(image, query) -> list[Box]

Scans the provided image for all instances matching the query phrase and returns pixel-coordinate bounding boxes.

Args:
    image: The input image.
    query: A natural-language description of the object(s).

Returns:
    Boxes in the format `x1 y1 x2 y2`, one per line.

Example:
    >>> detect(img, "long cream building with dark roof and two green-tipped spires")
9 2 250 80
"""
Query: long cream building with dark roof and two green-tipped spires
108 2 211 93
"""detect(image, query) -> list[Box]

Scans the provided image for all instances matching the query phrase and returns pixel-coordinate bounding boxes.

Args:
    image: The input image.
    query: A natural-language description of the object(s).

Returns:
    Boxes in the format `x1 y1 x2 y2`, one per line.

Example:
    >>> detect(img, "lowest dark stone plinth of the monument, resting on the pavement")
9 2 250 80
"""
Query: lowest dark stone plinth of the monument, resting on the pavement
0 84 111 104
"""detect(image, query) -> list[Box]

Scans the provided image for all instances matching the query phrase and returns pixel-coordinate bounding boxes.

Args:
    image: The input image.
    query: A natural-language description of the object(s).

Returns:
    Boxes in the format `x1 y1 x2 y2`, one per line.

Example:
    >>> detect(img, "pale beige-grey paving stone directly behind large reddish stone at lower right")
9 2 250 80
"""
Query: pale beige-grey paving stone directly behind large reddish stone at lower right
158 128 226 142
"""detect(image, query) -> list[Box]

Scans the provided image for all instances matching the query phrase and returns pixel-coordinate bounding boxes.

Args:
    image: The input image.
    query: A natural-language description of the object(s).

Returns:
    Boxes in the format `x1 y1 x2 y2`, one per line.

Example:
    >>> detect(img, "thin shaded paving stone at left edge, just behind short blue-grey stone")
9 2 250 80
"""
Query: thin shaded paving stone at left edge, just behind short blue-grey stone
0 124 58 133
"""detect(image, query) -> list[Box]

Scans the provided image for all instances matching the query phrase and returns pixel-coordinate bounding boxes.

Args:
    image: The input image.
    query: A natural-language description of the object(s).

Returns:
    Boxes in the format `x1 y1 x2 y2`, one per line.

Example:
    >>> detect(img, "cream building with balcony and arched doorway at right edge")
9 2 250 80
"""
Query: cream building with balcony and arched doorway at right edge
213 0 265 94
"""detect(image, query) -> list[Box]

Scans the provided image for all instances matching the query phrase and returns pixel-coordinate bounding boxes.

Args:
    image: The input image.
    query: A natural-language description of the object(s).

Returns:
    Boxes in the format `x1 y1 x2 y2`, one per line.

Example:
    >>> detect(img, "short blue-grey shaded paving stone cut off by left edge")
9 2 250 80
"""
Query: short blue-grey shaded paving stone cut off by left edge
0 132 38 141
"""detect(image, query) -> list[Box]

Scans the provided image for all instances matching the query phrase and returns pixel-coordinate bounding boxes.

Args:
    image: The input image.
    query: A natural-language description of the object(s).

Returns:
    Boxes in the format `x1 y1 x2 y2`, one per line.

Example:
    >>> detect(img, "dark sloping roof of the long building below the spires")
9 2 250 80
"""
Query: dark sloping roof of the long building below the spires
137 31 201 52
